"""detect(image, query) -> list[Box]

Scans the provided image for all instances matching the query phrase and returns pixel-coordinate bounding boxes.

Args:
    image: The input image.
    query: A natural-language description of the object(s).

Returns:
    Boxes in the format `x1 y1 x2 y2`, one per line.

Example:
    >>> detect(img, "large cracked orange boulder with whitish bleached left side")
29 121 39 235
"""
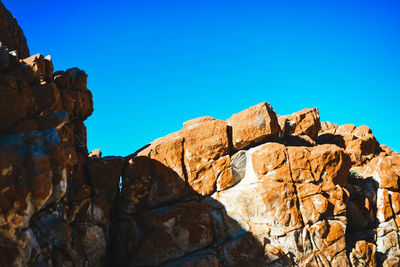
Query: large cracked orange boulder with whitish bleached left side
208 143 350 266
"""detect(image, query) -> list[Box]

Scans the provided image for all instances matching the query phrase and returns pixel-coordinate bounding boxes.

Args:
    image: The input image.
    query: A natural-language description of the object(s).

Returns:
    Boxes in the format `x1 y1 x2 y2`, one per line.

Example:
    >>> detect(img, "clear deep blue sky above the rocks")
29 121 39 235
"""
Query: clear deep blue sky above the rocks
3 0 400 155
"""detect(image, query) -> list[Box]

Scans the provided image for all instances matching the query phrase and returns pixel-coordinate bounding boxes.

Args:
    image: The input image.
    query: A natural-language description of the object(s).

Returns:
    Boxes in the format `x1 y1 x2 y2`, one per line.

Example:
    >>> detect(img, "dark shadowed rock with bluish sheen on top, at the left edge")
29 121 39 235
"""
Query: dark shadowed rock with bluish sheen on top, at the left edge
0 129 72 227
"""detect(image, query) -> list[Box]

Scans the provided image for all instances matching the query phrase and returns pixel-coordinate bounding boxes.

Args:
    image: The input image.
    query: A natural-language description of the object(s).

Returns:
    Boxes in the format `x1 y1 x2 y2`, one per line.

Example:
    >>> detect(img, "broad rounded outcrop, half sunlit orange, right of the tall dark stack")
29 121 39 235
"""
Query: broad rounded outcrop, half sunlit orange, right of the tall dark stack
113 103 400 266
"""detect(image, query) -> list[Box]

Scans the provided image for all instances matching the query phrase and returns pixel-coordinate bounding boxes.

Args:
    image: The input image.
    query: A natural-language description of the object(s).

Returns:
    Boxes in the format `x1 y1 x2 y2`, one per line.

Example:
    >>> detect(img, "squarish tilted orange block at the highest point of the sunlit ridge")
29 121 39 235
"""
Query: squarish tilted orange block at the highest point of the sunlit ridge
227 102 280 150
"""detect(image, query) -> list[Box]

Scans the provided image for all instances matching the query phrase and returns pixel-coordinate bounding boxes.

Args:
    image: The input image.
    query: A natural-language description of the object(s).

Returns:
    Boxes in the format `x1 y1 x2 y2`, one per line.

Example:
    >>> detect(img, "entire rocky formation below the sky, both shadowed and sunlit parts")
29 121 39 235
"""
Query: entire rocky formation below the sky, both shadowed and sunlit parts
0 1 400 267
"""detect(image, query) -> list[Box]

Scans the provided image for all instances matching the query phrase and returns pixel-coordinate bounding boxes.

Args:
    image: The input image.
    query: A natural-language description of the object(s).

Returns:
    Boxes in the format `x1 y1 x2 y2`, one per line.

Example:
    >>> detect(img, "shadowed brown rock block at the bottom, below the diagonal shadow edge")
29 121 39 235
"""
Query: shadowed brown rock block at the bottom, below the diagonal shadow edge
124 202 213 266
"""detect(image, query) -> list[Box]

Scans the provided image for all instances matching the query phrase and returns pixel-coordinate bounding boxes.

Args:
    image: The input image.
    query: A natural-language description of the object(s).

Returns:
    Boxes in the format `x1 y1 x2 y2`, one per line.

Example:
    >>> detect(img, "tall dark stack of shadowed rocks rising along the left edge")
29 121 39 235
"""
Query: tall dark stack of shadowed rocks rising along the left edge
0 3 124 266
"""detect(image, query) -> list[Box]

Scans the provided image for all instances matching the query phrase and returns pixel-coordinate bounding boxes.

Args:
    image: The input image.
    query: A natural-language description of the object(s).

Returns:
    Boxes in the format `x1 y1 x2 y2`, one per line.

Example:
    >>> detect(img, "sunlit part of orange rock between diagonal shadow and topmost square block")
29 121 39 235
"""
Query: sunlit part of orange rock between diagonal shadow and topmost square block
138 117 231 195
